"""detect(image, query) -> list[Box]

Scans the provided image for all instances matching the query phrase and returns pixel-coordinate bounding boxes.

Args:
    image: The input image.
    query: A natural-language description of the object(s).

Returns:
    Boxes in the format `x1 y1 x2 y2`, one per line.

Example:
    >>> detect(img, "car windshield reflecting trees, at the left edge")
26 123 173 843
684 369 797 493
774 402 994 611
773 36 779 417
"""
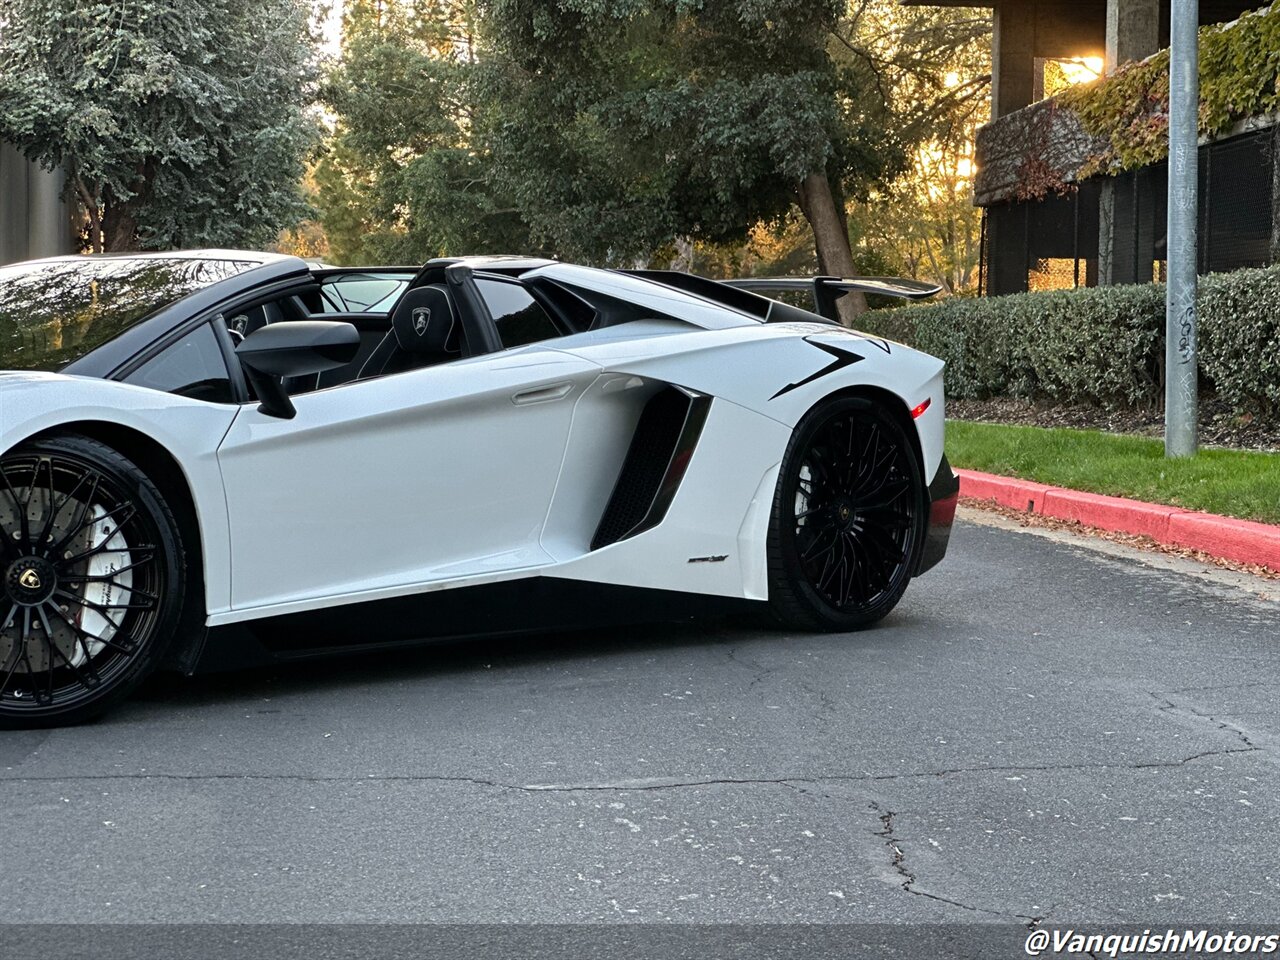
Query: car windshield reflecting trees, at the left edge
0 257 259 371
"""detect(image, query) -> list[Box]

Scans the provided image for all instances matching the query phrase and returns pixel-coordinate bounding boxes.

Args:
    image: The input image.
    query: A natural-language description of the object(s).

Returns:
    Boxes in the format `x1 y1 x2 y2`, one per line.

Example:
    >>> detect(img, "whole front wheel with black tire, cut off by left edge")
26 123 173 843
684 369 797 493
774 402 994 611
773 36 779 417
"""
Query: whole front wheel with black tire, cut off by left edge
0 435 186 730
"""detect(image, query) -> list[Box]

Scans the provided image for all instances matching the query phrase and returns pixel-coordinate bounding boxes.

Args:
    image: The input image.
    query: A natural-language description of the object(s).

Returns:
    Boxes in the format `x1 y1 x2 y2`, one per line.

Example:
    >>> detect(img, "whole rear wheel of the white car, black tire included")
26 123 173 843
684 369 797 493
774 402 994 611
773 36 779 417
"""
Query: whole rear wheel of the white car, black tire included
769 397 927 631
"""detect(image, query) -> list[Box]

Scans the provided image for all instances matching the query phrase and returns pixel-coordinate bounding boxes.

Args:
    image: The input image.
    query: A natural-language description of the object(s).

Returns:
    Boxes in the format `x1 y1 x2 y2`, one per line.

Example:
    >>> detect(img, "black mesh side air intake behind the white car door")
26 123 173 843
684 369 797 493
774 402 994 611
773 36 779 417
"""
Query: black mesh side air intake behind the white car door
591 387 712 550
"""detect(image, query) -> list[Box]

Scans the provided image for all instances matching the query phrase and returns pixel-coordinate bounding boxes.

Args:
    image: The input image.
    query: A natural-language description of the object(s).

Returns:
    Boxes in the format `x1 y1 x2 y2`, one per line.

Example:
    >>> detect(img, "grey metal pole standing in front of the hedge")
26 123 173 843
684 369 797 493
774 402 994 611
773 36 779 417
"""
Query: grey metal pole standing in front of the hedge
1165 0 1199 457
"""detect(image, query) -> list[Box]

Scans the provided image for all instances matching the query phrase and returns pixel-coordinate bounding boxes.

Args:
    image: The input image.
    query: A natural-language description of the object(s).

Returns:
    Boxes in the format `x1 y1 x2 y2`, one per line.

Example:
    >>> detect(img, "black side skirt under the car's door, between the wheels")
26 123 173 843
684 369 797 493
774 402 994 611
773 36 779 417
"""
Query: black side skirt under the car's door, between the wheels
189 577 763 673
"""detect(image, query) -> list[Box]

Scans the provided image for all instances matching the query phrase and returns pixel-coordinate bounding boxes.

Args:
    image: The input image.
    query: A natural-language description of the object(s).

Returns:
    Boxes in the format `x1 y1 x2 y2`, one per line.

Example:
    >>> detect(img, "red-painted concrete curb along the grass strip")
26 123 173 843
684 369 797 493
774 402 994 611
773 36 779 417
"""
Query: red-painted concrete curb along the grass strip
956 470 1280 571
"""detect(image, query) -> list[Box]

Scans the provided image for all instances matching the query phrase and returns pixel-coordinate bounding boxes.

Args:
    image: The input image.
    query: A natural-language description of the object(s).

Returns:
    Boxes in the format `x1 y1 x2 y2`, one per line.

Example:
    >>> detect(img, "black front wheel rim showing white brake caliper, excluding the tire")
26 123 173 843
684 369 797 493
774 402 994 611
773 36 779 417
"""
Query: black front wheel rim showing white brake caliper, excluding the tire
0 453 165 713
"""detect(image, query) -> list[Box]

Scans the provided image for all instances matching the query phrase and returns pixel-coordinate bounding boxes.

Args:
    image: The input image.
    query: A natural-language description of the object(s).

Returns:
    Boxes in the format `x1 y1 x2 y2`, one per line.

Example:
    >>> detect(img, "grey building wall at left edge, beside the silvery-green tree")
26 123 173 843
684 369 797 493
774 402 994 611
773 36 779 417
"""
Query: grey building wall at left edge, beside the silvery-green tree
0 143 76 264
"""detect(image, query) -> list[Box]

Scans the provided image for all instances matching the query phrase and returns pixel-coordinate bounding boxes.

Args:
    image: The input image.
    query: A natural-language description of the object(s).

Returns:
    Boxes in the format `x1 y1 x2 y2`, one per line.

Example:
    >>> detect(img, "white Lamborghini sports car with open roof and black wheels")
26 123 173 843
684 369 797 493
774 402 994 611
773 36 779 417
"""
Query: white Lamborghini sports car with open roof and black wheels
0 251 957 727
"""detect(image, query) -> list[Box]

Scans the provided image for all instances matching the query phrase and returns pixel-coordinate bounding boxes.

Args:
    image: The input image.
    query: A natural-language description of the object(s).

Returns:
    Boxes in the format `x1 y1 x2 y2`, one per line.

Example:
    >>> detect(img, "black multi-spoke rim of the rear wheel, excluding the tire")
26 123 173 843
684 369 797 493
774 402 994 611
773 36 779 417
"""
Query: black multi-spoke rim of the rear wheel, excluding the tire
794 410 920 613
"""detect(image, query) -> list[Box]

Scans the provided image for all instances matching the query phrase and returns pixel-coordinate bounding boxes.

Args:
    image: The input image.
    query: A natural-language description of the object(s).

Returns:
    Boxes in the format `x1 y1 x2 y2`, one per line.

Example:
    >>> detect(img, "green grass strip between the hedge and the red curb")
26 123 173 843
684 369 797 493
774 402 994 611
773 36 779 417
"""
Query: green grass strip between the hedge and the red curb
947 420 1280 524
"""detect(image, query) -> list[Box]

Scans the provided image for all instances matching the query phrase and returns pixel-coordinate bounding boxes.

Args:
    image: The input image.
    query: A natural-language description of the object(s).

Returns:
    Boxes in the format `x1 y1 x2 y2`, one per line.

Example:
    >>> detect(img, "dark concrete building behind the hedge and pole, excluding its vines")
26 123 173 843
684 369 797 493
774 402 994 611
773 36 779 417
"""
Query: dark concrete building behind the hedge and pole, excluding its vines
901 0 1280 296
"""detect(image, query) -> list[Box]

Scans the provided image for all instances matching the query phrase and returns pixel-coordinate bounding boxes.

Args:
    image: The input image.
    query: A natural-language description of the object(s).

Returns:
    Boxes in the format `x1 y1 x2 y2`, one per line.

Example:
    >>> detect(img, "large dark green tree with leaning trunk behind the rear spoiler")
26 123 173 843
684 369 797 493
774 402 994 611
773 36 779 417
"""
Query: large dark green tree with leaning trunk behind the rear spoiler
481 0 904 320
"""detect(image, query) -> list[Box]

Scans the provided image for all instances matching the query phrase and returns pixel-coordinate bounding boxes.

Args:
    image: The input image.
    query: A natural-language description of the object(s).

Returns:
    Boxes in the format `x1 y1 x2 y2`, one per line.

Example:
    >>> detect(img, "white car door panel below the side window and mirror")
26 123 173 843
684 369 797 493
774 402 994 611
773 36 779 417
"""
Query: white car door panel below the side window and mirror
218 344 599 612
